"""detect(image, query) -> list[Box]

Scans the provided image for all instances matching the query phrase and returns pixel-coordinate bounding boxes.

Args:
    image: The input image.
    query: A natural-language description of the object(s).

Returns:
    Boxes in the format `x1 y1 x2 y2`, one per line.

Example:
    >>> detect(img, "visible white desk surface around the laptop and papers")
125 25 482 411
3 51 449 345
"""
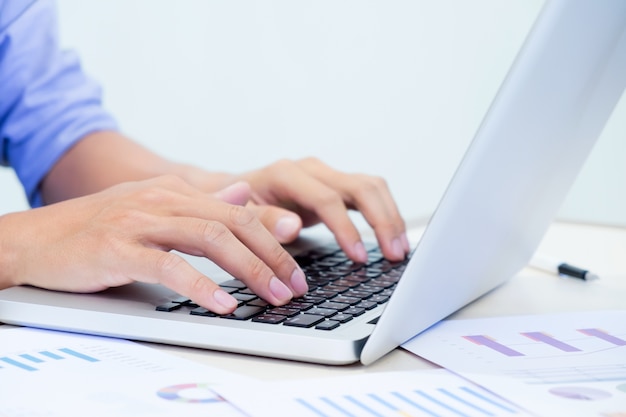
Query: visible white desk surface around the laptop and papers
0 223 626 380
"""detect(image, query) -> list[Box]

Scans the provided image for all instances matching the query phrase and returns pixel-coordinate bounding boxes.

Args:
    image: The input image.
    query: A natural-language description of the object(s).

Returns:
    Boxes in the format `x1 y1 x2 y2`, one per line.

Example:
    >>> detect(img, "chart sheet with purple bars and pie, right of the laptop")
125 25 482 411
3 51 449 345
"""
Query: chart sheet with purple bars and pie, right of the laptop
403 311 626 417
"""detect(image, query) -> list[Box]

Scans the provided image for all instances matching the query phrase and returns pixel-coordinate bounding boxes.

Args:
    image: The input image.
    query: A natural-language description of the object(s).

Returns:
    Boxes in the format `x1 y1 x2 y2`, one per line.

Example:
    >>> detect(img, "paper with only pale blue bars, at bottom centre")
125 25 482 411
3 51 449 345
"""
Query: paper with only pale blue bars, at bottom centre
217 369 530 417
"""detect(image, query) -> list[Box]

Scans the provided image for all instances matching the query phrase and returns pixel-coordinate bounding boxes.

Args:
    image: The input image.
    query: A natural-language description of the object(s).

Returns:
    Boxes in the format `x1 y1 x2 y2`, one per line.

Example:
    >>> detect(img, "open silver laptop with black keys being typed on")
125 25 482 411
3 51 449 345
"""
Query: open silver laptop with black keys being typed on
0 0 626 364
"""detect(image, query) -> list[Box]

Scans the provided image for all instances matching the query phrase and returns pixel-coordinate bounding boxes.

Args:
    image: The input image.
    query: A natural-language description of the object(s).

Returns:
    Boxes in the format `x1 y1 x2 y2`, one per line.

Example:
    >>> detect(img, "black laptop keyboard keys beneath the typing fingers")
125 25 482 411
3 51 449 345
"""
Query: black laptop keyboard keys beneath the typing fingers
156 244 408 330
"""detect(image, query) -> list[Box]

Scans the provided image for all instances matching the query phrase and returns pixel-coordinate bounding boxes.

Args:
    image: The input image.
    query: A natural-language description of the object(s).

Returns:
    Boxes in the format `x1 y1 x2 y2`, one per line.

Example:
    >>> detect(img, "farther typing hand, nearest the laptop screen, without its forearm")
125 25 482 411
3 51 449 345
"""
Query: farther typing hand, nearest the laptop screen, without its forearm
237 158 410 262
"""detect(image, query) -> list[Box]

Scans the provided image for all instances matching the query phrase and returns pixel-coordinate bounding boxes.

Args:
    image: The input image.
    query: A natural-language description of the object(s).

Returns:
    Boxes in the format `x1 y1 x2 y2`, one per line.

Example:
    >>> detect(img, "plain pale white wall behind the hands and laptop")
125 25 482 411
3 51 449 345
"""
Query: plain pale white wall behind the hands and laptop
0 0 626 225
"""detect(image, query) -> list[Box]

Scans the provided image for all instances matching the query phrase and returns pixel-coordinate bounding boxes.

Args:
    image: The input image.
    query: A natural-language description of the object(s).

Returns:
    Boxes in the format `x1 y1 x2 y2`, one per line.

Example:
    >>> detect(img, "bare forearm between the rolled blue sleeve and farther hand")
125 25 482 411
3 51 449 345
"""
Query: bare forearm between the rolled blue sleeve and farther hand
42 131 231 204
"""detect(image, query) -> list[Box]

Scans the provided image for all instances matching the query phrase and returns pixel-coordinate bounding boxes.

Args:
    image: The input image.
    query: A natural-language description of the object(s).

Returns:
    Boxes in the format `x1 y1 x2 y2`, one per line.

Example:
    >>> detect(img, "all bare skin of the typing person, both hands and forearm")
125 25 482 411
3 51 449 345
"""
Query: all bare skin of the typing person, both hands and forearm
0 132 409 314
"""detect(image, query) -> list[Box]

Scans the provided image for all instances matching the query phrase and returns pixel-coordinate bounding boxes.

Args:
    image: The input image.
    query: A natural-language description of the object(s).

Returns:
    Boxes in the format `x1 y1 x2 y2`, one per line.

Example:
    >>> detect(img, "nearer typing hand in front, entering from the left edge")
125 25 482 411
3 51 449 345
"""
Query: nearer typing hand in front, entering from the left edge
0 176 307 314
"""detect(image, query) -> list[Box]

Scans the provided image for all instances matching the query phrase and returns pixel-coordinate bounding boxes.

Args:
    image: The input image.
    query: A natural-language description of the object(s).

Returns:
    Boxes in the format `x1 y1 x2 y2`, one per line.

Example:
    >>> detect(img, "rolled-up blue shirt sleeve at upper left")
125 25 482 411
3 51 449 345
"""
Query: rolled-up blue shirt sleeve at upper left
0 0 117 207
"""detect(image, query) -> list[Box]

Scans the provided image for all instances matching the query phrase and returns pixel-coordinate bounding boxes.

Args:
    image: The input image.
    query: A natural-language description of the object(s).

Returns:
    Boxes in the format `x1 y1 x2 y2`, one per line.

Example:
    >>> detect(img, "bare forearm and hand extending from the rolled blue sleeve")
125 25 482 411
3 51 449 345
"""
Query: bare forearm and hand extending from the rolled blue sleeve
42 132 410 261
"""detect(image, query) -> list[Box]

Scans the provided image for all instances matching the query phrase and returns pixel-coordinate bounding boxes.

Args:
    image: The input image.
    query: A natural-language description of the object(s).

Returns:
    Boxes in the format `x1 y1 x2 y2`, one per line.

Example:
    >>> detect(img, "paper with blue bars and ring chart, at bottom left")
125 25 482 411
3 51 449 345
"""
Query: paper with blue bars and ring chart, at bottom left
0 328 249 417
